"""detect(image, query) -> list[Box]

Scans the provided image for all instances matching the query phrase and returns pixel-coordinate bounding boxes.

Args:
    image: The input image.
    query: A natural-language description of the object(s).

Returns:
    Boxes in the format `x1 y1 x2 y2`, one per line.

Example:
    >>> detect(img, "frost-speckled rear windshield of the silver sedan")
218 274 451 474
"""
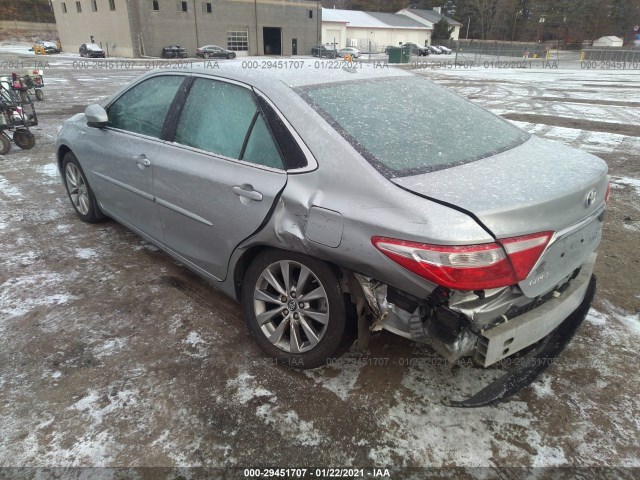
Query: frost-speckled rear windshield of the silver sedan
298 76 529 178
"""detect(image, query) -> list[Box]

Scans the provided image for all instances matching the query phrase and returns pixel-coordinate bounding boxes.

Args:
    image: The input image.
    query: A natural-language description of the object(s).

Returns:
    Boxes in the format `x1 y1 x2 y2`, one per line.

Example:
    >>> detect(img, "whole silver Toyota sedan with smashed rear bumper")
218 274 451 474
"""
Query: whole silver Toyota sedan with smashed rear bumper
56 65 609 406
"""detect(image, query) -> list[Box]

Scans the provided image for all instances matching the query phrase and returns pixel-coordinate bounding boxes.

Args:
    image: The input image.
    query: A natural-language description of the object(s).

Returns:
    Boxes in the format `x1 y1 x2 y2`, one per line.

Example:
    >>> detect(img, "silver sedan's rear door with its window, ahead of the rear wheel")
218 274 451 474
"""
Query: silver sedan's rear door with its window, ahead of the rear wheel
154 77 287 280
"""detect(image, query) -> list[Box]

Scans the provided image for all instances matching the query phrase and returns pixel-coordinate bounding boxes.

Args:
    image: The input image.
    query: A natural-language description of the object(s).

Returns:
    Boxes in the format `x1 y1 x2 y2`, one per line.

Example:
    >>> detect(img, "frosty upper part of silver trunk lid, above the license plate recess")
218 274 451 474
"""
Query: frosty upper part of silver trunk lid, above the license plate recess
392 136 608 238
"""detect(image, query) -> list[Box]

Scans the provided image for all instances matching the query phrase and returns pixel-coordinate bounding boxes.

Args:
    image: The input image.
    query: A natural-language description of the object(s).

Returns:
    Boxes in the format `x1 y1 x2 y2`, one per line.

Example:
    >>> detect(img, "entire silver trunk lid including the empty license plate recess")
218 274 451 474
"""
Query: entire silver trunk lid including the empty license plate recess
393 137 608 298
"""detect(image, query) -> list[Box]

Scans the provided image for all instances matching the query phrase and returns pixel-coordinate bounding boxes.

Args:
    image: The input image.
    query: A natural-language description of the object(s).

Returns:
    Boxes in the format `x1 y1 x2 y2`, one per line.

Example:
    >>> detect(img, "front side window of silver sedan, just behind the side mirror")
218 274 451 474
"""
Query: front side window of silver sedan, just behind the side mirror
107 75 184 138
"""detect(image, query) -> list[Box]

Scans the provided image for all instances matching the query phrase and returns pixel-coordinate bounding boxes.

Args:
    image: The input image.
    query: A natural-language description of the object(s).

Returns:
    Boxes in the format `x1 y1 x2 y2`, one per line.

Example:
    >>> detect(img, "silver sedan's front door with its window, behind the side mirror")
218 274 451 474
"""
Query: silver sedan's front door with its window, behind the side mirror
80 75 185 241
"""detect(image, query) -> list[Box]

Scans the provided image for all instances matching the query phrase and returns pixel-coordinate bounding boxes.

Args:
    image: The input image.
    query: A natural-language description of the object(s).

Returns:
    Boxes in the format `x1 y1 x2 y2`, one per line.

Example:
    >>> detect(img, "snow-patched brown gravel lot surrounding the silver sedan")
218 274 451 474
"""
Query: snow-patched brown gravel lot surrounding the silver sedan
0 46 640 478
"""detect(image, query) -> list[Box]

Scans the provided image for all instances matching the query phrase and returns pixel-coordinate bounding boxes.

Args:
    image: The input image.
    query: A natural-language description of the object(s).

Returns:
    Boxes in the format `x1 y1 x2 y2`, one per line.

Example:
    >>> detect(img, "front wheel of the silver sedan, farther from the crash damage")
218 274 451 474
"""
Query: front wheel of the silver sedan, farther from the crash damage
62 152 106 223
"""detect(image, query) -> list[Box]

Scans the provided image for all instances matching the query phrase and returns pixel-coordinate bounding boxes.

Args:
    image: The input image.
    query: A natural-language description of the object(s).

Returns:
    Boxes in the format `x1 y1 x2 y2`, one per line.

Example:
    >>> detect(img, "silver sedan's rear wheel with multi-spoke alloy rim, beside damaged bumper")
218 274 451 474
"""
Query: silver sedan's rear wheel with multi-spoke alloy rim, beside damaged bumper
242 250 348 369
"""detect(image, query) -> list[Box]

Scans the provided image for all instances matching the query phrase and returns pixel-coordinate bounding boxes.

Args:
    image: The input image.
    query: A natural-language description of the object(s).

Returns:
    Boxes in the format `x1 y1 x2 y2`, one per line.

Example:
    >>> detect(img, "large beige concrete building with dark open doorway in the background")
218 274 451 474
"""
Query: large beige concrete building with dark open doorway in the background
51 0 322 57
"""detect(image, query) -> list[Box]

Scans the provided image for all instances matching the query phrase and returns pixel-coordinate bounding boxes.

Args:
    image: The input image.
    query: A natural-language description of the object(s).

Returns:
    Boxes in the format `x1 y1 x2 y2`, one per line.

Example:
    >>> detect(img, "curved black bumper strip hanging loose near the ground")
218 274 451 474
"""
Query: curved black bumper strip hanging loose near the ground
443 275 596 408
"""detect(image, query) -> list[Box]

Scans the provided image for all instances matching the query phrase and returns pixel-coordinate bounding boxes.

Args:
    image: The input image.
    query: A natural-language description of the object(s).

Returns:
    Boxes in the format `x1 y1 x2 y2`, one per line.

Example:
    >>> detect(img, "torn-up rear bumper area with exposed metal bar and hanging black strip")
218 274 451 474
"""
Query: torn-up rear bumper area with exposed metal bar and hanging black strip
356 253 597 407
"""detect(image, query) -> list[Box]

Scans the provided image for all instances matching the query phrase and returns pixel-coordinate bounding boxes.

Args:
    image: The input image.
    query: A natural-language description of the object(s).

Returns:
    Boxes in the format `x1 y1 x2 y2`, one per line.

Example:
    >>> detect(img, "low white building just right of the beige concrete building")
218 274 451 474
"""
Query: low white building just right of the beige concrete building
322 8 432 52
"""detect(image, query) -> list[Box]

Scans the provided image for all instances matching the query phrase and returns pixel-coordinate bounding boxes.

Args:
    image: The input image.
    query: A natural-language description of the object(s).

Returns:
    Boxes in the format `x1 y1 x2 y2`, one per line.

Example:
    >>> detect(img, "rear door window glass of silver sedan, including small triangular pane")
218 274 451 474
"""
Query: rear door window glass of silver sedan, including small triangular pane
175 78 284 168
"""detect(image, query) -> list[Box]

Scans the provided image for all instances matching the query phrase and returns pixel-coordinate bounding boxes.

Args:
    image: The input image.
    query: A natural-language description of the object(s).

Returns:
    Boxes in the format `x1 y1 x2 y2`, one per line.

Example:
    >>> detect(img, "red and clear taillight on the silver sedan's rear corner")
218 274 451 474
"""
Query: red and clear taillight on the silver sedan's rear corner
371 232 553 290
